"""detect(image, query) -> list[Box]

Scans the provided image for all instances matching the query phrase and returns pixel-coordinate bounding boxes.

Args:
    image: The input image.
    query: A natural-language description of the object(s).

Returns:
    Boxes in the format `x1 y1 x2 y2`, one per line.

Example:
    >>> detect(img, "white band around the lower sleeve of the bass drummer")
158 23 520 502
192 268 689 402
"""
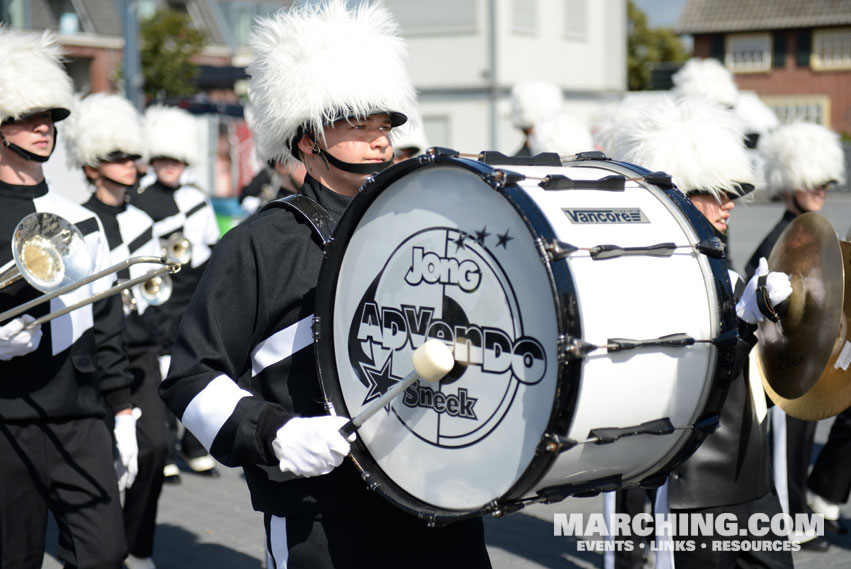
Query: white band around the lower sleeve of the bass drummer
180 375 251 450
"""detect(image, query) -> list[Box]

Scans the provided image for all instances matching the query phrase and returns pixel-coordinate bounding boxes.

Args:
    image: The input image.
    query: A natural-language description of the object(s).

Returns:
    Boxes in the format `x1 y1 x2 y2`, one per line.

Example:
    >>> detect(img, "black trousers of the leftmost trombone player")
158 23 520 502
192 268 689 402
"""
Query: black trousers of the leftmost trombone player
0 418 127 569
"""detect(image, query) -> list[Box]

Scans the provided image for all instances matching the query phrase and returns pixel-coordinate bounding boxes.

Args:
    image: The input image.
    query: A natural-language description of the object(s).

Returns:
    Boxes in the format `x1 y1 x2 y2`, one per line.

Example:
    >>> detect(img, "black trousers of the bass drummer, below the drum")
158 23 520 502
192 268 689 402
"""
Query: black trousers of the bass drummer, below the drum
263 503 491 569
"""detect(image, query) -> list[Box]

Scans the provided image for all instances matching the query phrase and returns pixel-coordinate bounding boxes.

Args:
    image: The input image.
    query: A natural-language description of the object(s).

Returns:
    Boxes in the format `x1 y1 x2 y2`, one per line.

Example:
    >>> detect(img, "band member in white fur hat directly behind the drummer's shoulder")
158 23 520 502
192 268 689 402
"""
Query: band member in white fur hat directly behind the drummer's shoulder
130 105 219 482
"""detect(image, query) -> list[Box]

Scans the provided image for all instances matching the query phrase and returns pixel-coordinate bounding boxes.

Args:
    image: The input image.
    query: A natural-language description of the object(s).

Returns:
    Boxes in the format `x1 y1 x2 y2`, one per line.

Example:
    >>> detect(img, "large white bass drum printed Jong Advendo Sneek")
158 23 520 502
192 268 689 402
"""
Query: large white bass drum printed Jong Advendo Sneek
316 152 734 521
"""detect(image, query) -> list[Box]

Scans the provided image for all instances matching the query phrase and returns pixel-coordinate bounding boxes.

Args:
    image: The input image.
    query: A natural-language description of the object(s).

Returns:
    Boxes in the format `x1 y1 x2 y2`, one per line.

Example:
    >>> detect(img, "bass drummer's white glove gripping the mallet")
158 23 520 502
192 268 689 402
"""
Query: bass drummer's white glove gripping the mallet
272 415 355 477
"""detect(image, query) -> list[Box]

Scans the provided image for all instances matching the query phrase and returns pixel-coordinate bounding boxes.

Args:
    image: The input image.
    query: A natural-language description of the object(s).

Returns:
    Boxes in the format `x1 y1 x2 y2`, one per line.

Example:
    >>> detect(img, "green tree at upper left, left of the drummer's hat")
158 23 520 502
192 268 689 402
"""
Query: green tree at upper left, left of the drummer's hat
139 10 207 98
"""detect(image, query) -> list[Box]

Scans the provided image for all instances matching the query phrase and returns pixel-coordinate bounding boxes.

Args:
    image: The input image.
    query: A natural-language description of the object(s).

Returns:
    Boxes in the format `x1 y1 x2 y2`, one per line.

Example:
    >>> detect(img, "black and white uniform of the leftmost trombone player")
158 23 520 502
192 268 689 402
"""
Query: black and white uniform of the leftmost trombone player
0 182 130 568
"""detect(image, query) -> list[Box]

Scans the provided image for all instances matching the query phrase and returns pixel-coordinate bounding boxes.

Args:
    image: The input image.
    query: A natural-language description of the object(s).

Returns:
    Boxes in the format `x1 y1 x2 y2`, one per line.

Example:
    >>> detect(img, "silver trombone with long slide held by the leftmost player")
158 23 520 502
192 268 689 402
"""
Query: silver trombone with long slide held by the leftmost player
0 212 180 328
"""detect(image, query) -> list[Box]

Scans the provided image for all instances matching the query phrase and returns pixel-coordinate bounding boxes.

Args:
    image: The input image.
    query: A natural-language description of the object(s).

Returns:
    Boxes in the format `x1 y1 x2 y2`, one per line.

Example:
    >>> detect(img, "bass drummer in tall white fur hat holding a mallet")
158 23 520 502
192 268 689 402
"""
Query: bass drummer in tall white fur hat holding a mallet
161 0 490 569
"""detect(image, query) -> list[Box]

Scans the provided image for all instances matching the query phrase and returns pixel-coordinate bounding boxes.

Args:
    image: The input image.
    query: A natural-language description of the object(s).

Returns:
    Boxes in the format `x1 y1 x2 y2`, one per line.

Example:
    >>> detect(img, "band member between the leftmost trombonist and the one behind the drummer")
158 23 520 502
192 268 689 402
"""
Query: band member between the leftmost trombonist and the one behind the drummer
64 93 168 569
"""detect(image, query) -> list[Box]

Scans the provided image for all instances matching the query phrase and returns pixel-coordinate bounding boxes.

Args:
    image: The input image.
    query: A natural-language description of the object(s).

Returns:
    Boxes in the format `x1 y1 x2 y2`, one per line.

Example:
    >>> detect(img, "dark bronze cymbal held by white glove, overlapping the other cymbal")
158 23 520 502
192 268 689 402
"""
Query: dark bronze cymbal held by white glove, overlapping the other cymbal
757 212 845 399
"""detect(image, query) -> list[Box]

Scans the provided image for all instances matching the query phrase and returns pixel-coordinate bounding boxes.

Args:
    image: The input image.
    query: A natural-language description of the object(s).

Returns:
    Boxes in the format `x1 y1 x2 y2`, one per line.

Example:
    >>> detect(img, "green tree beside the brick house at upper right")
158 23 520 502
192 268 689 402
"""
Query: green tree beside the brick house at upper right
626 0 689 91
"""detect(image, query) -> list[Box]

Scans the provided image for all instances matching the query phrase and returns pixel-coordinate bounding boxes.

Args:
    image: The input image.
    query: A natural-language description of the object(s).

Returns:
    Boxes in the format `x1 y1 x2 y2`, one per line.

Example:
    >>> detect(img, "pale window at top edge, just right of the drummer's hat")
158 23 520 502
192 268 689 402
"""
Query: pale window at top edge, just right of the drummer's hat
384 0 478 36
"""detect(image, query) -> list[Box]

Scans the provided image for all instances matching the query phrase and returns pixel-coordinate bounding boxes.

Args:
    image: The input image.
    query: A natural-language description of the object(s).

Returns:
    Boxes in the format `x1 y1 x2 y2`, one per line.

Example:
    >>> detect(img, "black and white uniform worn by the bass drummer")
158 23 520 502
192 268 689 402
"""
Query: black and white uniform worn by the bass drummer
161 177 490 569
